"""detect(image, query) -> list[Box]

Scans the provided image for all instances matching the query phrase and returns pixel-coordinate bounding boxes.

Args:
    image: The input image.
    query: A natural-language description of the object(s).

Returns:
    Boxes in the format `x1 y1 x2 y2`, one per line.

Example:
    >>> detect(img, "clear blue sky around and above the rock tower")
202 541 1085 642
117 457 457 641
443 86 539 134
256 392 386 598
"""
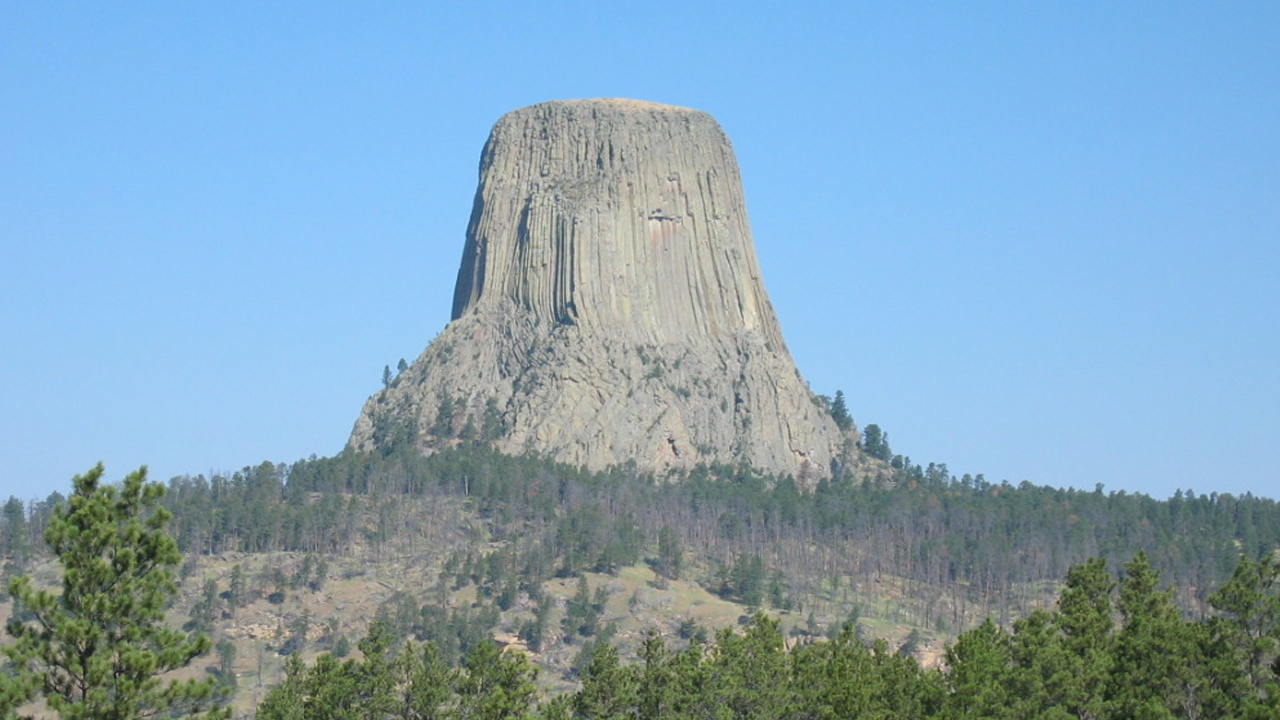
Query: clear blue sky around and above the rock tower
0 0 1280 500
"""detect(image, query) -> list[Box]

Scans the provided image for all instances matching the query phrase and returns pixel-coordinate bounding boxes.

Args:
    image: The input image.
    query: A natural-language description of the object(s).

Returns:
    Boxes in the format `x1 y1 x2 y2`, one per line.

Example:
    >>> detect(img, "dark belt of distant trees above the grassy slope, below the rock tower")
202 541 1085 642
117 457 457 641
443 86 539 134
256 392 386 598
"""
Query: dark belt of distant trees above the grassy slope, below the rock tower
0 445 1280 620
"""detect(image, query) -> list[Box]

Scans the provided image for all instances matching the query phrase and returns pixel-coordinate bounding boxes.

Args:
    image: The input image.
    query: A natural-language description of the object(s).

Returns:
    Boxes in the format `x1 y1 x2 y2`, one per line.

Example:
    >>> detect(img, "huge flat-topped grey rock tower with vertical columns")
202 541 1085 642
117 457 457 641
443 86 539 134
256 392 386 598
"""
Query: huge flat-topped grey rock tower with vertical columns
349 100 851 478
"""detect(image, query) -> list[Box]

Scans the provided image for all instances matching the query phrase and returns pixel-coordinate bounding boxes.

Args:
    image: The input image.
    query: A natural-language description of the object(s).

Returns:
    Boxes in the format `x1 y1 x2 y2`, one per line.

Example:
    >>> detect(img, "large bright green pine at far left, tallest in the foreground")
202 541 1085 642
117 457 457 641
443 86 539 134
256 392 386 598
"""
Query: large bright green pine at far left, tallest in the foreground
0 464 227 720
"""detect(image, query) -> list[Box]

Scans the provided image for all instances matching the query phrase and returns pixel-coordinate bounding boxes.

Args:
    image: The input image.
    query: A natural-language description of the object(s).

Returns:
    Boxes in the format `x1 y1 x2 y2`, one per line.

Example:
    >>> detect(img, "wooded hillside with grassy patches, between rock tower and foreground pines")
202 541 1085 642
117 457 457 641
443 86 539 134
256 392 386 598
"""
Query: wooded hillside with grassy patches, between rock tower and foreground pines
0 438 1280 712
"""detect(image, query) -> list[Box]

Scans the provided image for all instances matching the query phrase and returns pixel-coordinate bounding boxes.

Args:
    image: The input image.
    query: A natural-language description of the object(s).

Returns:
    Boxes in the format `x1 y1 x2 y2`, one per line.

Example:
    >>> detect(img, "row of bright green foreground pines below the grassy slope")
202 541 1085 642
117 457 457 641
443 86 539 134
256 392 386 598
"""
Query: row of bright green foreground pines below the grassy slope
259 543 1280 720
